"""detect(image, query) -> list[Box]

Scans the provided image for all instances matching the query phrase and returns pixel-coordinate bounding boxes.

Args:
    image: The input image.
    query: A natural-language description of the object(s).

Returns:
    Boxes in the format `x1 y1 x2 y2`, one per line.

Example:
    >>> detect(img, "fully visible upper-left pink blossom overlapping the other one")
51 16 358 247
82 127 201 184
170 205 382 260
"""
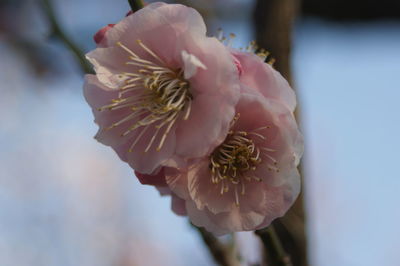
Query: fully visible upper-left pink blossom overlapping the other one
84 3 240 174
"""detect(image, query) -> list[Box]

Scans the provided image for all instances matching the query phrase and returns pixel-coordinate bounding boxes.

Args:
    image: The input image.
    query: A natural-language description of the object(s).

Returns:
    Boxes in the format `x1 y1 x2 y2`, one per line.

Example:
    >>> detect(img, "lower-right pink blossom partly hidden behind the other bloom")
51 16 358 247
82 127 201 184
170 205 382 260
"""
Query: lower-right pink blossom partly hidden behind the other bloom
142 89 303 235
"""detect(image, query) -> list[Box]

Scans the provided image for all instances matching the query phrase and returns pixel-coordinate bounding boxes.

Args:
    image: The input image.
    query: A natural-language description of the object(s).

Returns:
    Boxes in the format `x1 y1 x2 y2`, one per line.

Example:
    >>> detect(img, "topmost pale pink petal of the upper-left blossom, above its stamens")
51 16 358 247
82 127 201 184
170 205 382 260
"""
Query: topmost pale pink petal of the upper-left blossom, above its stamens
100 3 206 66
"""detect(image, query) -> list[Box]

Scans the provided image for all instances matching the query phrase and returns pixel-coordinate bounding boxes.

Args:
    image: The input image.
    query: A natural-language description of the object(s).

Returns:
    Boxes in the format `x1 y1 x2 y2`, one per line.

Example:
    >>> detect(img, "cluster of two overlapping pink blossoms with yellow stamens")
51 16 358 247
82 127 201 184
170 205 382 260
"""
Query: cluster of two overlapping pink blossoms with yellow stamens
84 3 303 234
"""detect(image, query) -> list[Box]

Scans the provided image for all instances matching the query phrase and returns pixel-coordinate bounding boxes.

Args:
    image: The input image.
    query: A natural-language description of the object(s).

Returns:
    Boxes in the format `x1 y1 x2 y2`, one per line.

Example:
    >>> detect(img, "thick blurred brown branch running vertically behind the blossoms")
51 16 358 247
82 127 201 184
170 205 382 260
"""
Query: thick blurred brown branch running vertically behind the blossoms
254 0 308 266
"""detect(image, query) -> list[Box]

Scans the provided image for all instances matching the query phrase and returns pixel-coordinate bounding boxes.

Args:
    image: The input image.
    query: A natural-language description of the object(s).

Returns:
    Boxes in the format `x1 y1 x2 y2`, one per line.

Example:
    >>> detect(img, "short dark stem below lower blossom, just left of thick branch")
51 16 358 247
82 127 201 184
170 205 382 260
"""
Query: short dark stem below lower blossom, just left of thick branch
255 225 293 266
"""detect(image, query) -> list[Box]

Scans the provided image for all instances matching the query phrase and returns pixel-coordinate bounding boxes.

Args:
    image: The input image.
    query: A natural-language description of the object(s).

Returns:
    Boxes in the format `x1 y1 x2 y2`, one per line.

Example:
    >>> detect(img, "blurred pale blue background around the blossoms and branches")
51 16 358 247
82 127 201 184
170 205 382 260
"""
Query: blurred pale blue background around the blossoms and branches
0 0 400 266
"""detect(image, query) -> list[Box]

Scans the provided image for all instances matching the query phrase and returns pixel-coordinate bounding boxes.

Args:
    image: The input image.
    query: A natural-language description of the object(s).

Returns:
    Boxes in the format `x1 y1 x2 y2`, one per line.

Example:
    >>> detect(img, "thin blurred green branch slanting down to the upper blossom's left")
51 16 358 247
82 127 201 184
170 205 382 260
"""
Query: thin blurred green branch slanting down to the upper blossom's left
42 0 93 73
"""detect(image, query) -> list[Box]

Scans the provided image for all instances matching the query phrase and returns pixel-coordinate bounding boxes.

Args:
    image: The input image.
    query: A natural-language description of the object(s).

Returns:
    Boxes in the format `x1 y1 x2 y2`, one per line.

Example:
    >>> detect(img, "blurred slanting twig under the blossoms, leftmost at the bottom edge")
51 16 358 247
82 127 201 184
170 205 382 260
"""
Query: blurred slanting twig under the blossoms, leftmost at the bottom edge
192 224 240 266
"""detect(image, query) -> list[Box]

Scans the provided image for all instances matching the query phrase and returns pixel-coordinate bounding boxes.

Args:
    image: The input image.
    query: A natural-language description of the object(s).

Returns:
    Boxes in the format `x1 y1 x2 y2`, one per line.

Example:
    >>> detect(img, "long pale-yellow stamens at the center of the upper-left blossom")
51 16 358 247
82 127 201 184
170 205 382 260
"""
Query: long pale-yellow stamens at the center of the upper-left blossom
99 40 193 152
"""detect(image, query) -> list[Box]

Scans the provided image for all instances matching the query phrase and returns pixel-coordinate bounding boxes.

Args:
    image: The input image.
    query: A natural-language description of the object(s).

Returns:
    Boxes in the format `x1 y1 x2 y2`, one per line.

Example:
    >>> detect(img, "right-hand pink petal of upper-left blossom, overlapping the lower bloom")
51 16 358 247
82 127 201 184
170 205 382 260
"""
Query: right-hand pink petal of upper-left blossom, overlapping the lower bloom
176 35 240 158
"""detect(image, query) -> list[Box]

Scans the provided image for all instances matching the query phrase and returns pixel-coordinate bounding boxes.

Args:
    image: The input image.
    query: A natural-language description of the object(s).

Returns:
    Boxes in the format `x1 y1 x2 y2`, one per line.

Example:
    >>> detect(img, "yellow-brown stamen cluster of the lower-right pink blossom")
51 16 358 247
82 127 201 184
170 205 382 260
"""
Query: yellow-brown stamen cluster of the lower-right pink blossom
209 115 279 206
